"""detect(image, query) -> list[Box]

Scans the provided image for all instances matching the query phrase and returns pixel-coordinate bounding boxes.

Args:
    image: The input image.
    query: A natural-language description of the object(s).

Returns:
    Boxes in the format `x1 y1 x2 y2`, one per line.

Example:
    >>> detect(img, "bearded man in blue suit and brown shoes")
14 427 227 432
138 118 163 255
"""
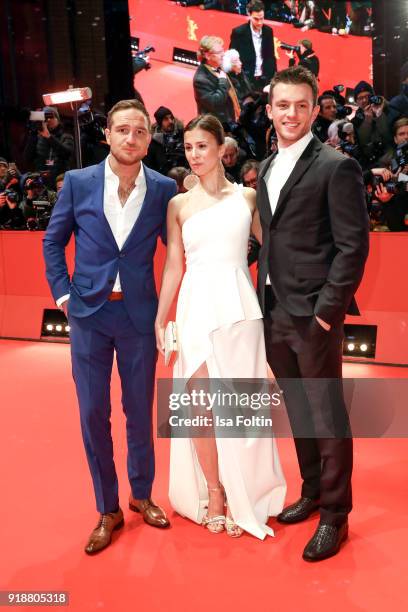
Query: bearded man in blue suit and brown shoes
44 100 176 554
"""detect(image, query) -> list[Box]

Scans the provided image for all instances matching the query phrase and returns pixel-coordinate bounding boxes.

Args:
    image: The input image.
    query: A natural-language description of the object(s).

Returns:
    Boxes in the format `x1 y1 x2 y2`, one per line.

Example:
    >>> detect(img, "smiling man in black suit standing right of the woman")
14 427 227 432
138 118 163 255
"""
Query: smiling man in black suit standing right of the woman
257 66 368 561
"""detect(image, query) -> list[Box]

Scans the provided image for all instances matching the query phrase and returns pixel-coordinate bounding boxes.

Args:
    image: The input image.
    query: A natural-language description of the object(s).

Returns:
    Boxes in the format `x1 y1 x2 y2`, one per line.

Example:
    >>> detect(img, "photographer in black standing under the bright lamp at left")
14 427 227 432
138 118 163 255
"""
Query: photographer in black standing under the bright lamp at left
24 106 74 186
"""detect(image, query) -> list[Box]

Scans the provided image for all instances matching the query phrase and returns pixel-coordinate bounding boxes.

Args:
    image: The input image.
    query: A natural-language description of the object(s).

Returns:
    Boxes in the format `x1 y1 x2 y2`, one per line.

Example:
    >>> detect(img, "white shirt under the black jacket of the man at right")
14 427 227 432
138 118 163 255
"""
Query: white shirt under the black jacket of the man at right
264 132 313 285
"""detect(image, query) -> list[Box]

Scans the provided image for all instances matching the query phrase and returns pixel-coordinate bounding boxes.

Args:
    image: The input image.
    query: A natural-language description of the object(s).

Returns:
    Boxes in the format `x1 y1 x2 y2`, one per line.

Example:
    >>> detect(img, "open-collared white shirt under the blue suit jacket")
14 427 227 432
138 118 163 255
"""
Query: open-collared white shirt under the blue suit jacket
57 155 147 306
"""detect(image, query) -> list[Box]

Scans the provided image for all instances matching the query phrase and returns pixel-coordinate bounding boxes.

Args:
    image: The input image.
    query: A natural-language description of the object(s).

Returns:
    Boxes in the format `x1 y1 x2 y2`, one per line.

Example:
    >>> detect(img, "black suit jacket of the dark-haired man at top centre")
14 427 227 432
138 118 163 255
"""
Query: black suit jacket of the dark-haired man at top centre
230 21 276 80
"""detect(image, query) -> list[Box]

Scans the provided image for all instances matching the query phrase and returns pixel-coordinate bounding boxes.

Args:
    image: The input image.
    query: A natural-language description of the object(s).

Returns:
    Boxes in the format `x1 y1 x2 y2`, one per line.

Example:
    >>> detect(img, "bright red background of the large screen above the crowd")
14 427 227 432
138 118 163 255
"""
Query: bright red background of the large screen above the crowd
129 0 372 95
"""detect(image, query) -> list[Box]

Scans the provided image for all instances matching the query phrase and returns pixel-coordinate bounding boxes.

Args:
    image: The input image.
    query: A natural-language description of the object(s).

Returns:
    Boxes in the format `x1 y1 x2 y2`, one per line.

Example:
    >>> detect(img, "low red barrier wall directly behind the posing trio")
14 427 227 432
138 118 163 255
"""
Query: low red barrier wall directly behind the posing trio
0 231 408 365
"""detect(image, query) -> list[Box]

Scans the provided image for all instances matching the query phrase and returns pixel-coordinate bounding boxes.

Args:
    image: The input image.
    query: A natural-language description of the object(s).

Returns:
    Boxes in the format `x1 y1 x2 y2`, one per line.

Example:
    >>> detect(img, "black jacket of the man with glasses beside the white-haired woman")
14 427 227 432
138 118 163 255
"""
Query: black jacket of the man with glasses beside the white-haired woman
193 64 235 123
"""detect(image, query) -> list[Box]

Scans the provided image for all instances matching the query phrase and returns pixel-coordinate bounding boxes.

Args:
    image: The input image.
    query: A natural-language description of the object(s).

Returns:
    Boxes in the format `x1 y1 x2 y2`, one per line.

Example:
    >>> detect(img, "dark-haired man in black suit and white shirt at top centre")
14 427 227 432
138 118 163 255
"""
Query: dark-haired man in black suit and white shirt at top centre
230 0 276 91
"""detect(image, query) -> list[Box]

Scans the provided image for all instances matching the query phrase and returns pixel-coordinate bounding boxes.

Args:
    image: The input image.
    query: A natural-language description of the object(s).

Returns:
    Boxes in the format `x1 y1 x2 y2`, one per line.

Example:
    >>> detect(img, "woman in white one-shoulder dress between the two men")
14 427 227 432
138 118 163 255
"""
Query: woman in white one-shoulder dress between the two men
156 115 286 539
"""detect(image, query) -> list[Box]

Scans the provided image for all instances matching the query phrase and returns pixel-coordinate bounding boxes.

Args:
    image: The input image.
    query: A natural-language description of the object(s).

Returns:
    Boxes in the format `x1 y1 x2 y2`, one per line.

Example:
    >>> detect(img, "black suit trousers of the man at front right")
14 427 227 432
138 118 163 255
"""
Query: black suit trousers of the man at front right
264 288 353 525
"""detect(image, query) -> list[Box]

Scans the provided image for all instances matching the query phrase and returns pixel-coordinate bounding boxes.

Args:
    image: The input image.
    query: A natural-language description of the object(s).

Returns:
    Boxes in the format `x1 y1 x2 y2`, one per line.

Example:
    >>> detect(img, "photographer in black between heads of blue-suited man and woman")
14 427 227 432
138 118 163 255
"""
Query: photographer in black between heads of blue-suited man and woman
143 106 187 175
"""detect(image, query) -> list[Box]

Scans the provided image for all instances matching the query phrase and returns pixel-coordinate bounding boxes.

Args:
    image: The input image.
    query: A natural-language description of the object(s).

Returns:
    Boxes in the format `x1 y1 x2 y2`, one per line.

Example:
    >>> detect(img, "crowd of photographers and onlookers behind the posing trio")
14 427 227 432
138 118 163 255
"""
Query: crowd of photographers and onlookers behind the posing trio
0 0 408 231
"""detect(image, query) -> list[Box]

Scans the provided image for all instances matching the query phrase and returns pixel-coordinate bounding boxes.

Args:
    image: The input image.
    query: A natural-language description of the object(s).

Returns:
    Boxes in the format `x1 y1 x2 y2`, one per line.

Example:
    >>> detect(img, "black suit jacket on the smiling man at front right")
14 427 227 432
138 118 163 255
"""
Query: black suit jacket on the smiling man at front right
257 137 369 324
